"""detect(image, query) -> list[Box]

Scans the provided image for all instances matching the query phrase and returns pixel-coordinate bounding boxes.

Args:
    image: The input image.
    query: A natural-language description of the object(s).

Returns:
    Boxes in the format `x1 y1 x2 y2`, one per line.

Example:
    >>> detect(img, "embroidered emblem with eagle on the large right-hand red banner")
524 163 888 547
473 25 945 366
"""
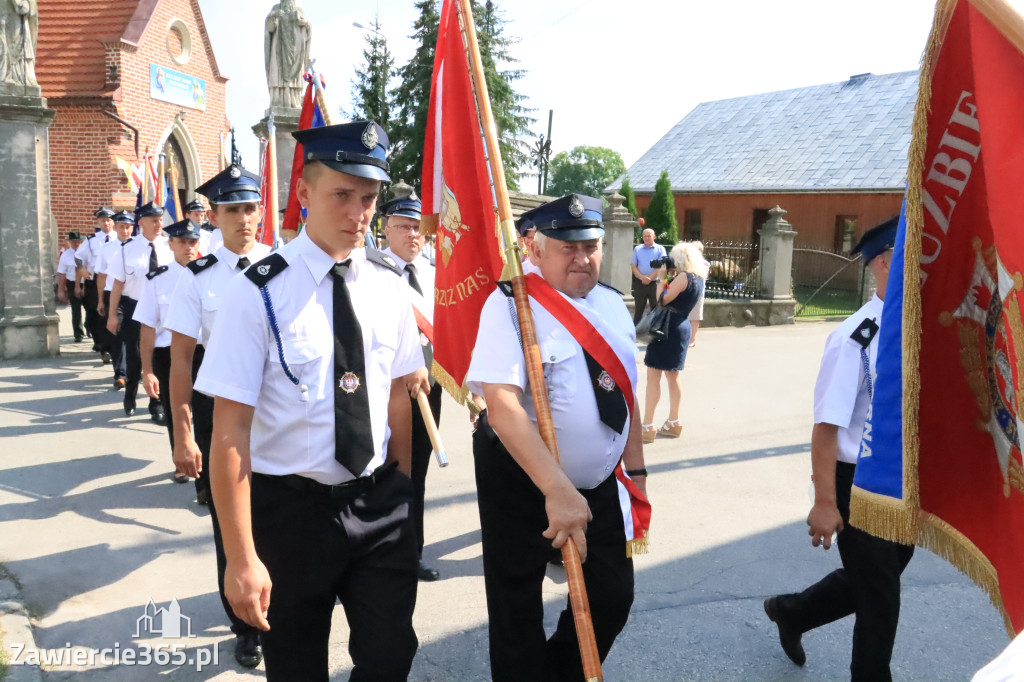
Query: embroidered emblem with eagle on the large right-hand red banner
939 238 1024 497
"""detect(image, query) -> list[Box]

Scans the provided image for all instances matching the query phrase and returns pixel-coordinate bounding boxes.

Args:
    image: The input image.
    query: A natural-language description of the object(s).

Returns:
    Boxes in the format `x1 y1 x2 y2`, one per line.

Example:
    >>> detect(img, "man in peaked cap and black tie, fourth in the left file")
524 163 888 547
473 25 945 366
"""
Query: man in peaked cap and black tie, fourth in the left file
106 202 174 413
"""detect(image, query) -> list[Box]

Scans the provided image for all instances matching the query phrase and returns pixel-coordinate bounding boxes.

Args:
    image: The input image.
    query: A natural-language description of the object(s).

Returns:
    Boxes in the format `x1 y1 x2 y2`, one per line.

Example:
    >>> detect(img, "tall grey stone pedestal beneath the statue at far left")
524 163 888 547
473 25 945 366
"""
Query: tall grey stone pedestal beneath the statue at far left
0 90 60 359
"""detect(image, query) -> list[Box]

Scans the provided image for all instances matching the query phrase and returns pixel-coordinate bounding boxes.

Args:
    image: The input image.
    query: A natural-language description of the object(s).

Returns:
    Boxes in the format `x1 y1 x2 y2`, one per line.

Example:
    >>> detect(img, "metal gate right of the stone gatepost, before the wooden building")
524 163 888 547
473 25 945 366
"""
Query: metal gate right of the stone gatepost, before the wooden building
793 249 866 317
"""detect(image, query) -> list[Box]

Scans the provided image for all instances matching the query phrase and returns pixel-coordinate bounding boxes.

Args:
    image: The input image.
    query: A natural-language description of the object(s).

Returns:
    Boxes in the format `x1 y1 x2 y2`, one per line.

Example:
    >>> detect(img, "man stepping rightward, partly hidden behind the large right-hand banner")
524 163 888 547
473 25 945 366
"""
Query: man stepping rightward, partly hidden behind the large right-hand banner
764 217 913 682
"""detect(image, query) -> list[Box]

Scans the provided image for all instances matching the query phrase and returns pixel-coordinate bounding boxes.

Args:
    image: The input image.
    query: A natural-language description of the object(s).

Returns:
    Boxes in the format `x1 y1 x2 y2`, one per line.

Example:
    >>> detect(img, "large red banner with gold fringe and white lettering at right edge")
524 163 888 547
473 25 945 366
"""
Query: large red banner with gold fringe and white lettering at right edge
852 0 1024 633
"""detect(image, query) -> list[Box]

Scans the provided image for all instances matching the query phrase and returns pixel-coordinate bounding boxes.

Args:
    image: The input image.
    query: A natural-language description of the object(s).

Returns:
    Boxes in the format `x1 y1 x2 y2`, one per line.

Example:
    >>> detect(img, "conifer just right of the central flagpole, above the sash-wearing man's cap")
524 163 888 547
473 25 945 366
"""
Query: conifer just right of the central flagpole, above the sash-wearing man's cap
473 0 535 189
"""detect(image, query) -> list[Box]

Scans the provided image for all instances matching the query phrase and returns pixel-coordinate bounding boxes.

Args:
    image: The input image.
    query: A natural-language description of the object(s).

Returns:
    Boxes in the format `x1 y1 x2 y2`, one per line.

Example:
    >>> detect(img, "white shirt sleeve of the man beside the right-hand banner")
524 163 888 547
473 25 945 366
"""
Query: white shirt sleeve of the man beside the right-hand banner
814 333 863 429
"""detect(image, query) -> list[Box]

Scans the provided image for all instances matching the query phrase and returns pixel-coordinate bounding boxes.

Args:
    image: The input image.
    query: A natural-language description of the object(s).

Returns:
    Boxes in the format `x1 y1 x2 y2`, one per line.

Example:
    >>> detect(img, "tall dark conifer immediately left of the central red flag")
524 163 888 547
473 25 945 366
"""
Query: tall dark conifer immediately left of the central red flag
387 0 440 188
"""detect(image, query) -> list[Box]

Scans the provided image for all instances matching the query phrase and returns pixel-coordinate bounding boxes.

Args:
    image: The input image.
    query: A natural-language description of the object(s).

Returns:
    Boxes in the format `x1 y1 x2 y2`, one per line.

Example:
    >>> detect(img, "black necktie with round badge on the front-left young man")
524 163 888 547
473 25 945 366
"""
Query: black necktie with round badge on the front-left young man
331 260 374 477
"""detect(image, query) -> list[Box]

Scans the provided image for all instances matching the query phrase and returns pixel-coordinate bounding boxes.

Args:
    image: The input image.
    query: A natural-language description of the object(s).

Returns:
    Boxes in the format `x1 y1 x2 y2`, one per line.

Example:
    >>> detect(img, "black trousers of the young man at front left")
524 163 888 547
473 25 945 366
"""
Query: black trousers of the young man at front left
252 468 419 682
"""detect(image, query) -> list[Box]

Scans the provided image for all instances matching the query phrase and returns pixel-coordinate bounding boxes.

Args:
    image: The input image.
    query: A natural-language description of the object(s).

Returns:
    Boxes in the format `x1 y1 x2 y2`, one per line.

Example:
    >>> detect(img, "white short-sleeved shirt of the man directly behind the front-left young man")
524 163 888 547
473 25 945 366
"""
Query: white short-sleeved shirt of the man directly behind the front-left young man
165 242 270 346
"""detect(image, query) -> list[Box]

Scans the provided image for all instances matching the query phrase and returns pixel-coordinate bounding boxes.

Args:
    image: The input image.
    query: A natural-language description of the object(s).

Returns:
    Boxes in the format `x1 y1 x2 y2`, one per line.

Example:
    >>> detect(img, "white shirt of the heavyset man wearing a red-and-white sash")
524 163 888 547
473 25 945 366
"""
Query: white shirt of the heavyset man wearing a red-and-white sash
466 274 637 488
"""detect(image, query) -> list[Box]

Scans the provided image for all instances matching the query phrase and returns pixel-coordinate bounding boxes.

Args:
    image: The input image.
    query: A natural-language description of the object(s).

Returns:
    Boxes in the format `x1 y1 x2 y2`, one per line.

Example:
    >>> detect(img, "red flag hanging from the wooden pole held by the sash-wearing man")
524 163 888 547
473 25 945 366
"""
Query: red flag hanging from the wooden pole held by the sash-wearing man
422 0 504 401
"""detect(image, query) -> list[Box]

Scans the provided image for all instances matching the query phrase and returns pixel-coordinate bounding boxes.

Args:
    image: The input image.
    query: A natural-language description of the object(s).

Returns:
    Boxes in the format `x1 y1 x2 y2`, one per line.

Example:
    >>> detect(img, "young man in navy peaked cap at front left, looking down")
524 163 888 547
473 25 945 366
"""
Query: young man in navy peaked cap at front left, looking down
196 121 429 682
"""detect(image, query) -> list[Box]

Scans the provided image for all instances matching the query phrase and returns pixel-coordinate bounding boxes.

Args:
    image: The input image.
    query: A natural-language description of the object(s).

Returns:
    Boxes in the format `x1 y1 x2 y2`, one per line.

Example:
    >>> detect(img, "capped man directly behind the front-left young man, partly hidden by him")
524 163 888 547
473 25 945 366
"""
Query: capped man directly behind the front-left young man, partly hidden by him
166 166 270 668
